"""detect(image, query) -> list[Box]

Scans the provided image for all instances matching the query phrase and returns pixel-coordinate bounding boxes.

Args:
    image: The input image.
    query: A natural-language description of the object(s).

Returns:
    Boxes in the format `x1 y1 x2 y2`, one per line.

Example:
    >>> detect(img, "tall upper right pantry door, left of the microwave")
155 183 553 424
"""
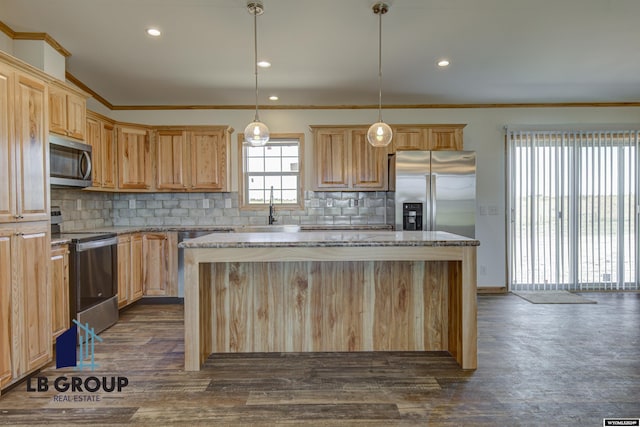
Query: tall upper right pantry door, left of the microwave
14 73 49 222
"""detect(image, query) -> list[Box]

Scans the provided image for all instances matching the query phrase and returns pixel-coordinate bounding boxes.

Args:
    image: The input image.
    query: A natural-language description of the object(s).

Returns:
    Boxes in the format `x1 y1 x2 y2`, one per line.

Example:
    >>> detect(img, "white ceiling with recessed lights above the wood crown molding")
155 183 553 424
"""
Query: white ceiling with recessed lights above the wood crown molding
0 0 640 106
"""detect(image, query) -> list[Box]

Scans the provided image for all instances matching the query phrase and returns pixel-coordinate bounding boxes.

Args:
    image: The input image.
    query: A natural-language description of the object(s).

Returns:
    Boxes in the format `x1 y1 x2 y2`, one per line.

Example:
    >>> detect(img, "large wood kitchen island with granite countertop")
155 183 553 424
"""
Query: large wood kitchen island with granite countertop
180 231 479 371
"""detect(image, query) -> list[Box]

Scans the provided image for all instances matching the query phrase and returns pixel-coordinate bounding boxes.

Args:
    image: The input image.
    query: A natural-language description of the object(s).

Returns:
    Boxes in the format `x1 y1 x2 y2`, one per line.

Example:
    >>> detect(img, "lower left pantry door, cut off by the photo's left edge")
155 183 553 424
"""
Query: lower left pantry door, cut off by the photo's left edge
0 228 13 388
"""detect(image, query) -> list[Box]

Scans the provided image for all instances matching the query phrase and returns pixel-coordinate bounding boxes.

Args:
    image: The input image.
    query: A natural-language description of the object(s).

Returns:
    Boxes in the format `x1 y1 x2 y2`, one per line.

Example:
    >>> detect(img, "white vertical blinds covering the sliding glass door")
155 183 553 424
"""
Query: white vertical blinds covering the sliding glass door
507 129 640 291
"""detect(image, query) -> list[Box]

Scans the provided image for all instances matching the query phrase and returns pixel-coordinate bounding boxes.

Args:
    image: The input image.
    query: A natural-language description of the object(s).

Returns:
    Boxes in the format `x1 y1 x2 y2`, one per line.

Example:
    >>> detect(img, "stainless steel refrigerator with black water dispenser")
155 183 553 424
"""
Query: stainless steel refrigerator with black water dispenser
391 151 476 238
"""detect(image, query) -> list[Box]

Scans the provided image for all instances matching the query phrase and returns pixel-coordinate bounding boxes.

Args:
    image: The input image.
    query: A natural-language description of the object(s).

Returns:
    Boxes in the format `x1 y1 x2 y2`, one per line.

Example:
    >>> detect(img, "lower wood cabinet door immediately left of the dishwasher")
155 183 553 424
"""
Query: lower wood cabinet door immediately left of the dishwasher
143 233 168 296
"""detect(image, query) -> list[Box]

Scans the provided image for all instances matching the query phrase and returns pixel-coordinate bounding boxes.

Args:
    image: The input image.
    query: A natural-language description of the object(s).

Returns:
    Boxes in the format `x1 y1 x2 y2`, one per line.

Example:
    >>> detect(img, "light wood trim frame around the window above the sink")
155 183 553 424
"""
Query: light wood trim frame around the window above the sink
238 133 305 210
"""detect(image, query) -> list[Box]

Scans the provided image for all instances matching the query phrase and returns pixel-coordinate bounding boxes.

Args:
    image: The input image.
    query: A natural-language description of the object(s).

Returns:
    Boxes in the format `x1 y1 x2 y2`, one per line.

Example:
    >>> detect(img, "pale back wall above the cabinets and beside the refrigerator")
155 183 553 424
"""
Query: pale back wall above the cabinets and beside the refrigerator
108 107 640 286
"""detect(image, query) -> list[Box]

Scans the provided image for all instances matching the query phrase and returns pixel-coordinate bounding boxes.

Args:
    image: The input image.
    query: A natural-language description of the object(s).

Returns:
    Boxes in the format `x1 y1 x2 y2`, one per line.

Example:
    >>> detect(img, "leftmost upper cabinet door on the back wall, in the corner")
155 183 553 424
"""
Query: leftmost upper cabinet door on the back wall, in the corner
118 128 151 189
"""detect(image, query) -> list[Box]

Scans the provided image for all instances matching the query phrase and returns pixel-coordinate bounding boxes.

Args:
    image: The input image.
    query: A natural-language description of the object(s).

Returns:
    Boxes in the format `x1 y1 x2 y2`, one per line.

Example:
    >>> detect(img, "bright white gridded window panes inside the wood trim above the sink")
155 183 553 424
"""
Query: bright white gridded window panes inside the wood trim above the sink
242 135 302 207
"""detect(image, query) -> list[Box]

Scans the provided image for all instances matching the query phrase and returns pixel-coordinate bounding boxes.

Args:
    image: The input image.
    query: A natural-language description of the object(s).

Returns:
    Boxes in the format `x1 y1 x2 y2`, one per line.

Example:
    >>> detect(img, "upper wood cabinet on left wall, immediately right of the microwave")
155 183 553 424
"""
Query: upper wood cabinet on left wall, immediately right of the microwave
87 112 116 189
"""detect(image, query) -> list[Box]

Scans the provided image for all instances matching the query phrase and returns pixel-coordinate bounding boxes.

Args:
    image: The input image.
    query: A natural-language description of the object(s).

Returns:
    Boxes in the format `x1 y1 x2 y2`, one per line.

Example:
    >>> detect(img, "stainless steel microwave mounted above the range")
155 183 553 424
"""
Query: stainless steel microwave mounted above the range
49 134 92 187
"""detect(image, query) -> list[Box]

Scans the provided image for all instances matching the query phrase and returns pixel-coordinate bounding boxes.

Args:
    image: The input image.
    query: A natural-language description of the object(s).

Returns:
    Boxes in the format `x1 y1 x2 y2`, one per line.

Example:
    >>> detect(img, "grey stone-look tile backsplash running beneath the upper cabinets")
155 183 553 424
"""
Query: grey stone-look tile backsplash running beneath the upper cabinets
51 189 394 231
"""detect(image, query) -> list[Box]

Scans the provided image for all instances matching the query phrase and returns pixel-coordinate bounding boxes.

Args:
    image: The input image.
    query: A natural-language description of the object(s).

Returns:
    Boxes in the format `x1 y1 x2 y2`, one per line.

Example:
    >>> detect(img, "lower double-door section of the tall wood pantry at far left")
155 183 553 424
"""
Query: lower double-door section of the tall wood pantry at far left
0 221 52 387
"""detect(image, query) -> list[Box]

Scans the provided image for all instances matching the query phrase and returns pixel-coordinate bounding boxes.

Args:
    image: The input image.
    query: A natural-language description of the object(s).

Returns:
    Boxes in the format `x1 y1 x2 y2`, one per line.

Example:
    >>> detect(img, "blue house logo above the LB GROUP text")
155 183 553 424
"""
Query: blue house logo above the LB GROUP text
56 319 103 371
